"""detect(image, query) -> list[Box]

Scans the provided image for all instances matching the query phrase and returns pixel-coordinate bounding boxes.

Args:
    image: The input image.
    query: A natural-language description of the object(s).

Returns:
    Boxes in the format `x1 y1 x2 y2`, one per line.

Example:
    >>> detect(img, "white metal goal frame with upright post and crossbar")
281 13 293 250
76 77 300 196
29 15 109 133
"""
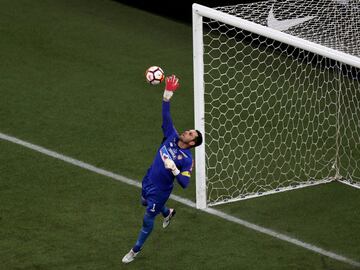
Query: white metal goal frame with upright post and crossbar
192 3 360 209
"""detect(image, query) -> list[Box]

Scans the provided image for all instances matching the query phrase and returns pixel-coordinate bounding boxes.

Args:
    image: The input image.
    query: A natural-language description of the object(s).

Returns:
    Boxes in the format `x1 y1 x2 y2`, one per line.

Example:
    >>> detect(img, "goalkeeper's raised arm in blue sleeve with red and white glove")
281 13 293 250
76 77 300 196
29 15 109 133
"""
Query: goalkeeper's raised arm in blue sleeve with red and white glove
161 75 180 137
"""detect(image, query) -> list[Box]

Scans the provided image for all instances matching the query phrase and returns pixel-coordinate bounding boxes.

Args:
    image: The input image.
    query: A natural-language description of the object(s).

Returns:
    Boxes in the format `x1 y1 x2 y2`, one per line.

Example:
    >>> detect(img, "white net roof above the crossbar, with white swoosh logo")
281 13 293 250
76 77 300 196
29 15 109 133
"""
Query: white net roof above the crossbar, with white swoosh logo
216 0 360 56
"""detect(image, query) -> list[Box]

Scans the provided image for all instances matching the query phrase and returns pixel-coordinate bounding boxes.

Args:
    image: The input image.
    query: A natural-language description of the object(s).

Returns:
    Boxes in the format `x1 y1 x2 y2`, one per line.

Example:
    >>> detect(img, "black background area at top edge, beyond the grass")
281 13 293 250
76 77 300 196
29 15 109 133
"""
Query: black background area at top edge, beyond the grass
115 0 258 23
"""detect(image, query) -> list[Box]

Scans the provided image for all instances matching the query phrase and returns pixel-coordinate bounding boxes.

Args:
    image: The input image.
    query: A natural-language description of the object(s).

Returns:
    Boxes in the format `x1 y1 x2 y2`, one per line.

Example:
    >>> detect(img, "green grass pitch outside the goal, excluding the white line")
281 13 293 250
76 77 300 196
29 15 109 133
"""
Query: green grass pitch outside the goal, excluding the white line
0 0 360 270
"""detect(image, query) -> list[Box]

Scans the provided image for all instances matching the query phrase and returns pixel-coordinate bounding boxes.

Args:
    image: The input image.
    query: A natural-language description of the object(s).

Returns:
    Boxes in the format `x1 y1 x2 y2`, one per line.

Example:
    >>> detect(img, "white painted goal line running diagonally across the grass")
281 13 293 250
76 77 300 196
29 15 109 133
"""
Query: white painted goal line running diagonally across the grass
0 133 360 267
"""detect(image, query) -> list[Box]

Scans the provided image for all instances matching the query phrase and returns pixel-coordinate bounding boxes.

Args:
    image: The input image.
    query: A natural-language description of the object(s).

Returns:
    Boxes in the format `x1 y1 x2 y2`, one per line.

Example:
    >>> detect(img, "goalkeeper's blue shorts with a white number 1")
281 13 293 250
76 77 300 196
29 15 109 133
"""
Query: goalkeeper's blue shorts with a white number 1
141 176 171 216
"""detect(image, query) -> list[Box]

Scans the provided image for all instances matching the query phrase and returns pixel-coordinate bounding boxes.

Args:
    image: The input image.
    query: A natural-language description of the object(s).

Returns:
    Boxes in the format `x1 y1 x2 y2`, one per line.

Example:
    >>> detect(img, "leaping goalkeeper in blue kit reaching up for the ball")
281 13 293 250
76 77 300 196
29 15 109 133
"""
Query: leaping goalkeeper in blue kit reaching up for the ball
122 75 202 263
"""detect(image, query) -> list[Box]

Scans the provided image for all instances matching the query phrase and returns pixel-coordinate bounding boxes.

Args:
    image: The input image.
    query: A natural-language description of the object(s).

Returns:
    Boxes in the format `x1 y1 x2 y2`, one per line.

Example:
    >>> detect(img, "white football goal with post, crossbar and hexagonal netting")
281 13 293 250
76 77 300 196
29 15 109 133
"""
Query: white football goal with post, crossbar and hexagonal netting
193 0 360 208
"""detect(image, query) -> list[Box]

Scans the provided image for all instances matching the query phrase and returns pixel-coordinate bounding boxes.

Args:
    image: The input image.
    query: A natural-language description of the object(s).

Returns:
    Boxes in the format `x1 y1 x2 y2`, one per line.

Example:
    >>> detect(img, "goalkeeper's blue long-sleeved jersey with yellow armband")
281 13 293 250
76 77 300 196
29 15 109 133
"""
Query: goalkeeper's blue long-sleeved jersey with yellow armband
143 101 192 193
